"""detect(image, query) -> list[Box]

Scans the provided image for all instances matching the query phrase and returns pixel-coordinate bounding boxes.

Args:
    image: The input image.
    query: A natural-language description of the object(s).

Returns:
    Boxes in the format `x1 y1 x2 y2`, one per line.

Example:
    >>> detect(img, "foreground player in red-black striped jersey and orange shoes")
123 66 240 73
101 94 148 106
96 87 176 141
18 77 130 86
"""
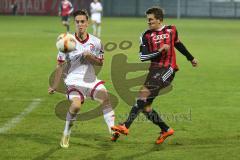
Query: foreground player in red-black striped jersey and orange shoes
112 7 198 144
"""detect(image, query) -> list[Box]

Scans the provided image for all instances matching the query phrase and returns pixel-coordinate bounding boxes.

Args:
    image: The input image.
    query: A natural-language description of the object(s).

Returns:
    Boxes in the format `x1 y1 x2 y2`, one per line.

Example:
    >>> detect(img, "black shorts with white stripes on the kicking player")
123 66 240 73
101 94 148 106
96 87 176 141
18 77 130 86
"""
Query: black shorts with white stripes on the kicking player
144 67 175 99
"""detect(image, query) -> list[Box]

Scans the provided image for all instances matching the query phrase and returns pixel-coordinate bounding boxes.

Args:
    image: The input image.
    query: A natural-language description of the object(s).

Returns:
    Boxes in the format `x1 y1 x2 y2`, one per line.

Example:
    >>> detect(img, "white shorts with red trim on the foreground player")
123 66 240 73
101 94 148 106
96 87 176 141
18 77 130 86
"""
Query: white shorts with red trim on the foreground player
66 79 106 103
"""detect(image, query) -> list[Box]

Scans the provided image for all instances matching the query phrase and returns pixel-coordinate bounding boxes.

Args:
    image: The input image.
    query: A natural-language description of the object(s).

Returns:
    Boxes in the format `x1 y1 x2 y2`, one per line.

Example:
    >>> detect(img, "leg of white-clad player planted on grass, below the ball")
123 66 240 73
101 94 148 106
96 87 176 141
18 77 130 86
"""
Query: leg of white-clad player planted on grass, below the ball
60 97 81 148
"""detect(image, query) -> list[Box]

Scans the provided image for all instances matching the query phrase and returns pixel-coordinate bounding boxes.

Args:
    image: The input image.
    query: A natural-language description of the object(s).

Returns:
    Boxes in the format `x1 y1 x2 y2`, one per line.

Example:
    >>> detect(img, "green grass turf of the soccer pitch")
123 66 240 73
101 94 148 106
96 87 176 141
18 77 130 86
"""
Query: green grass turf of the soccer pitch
0 16 240 160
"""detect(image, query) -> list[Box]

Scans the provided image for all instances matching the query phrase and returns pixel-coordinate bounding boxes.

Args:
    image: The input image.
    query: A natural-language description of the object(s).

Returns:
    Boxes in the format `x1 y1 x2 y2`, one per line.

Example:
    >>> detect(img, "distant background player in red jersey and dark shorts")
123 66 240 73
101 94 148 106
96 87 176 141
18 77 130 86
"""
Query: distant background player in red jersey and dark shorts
58 0 73 32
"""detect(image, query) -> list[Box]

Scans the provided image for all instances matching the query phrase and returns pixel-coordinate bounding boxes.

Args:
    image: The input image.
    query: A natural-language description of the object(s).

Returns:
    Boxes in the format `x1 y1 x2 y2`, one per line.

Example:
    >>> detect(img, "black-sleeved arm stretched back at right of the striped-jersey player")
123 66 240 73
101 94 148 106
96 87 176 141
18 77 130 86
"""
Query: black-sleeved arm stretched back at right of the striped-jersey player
174 27 198 67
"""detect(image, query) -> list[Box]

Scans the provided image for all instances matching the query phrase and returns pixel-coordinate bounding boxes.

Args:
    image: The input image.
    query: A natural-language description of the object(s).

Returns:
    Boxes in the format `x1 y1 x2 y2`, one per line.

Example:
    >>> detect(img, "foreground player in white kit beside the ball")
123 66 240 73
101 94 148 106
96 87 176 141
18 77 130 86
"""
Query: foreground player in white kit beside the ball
48 10 119 148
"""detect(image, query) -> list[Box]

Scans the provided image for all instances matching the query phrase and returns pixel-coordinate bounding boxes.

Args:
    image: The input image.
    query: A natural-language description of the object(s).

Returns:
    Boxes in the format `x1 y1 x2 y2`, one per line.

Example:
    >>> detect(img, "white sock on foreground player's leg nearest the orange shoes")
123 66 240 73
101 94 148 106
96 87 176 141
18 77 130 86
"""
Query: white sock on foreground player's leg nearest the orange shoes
103 108 115 134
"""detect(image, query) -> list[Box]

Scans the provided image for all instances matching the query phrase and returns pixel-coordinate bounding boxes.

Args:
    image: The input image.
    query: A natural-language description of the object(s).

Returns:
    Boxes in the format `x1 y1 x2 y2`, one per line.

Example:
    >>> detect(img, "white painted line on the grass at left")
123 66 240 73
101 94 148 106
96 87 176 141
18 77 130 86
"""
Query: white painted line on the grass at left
0 99 42 134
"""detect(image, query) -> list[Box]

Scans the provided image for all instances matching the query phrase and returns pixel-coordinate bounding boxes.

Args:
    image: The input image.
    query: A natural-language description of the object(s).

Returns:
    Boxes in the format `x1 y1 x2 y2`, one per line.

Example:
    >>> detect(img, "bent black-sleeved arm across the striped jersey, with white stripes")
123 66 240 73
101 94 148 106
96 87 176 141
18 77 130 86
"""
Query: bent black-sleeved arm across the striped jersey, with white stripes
139 34 169 62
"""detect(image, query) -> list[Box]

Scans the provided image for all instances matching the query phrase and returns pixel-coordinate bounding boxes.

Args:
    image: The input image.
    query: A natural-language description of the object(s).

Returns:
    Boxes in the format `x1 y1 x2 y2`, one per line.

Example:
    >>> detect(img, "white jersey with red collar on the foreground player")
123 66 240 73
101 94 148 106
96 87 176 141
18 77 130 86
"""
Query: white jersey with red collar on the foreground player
57 34 104 85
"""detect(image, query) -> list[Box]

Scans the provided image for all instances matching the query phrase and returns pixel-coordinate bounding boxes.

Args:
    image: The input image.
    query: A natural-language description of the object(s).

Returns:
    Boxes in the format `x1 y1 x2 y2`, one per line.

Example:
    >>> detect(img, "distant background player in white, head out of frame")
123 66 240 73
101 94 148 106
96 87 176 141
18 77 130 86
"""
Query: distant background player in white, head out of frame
90 0 103 37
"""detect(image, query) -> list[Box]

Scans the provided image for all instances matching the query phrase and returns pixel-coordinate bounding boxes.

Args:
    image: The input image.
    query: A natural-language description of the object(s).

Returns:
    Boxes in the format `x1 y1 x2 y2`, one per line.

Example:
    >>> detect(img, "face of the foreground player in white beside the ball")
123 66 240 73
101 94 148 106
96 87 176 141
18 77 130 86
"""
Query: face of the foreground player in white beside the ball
75 15 88 34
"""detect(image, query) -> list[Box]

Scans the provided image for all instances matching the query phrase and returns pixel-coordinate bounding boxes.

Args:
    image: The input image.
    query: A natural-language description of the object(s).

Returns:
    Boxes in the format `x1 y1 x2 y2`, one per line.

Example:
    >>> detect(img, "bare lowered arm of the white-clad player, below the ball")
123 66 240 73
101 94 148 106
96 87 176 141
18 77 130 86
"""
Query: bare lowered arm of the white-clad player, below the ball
48 63 63 94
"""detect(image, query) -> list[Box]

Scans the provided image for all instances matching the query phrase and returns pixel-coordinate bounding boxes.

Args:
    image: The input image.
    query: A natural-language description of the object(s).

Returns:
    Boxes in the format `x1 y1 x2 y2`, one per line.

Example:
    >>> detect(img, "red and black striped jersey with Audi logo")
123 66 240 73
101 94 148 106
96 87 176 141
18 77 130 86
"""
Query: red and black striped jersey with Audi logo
140 25 193 70
